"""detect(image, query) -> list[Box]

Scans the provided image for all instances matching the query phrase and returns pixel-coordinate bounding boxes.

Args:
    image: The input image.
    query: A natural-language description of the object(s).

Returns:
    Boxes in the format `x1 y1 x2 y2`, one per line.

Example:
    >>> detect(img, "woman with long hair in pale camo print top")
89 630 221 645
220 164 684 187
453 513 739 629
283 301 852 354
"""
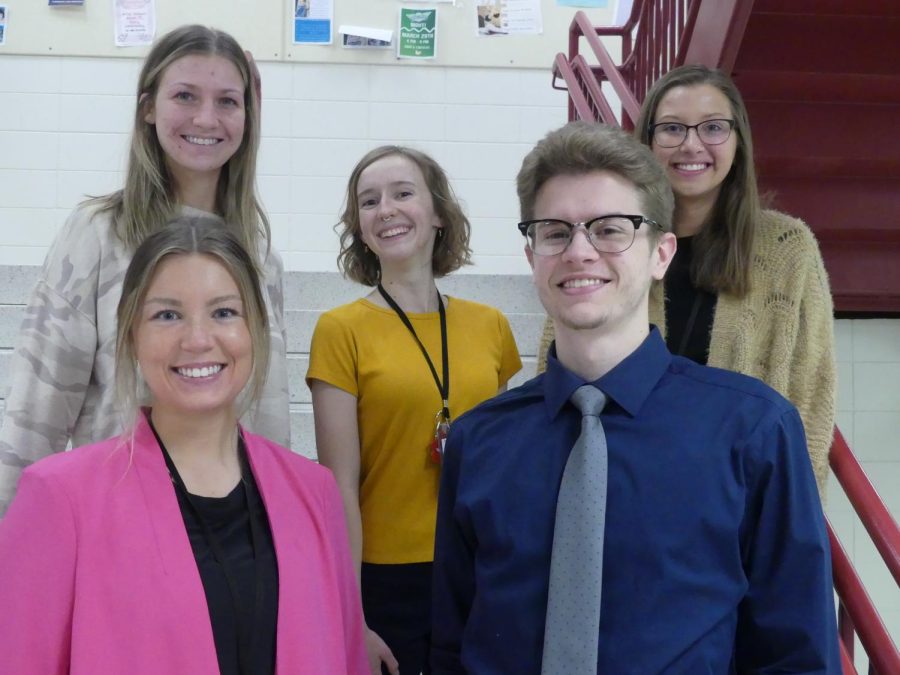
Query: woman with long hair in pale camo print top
0 26 290 514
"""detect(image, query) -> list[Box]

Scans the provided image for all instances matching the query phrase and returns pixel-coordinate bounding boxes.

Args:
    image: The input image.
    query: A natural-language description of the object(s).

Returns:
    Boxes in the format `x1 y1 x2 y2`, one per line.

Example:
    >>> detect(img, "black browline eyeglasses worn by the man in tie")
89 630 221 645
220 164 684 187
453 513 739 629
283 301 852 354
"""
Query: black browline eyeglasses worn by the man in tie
519 213 663 255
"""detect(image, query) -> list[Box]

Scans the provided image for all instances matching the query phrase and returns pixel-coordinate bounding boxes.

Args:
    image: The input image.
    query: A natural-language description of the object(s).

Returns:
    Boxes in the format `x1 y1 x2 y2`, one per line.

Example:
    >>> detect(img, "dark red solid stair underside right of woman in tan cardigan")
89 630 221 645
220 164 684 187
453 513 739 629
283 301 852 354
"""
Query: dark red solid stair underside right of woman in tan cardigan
733 0 900 312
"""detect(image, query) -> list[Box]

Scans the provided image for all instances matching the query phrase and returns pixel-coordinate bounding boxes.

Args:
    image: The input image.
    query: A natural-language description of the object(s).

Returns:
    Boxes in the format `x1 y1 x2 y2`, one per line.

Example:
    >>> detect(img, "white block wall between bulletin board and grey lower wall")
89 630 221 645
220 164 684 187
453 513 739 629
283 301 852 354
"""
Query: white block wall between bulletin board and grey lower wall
0 55 566 274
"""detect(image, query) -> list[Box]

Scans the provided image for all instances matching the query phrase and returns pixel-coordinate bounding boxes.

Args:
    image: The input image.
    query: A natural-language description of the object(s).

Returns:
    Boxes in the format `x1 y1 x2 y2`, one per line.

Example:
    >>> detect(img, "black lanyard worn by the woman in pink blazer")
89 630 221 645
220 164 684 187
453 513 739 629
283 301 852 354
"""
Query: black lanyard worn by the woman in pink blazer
147 415 263 675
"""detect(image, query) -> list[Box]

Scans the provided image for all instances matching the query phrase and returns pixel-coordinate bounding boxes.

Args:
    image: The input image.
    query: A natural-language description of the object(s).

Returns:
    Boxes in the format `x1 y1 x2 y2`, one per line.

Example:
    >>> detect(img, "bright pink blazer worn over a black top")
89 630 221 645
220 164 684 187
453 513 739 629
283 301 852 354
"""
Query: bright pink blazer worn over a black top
0 415 369 675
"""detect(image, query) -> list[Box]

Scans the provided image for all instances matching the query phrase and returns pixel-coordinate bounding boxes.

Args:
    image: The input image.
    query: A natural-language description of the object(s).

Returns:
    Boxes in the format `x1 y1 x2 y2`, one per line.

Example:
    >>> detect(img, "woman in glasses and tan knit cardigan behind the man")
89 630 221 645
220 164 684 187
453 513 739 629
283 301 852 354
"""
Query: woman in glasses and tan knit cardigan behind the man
538 66 835 495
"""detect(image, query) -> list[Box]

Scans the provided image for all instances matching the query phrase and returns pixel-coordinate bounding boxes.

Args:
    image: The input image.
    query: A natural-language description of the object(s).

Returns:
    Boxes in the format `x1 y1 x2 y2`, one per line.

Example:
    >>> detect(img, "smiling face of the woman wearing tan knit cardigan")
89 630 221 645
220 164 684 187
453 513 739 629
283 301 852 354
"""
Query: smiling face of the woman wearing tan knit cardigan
651 84 738 214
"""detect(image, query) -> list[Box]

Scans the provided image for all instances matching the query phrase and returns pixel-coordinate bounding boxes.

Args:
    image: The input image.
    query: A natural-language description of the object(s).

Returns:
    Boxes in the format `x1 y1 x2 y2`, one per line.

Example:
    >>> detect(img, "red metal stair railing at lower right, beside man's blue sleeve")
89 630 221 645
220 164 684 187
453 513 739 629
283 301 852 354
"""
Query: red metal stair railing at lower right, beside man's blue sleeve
828 427 900 675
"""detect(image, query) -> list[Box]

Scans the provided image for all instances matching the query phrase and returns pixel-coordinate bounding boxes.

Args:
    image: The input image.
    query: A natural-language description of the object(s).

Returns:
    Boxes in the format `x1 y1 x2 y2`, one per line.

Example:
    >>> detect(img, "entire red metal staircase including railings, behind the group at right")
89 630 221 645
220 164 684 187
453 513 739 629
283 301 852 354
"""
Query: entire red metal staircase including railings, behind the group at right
553 0 900 675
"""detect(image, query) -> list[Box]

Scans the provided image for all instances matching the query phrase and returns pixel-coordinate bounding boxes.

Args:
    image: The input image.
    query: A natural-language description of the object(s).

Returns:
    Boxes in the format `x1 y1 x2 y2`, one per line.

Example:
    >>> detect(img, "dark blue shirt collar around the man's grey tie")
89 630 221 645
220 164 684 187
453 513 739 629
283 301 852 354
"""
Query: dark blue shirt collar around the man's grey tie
544 326 672 418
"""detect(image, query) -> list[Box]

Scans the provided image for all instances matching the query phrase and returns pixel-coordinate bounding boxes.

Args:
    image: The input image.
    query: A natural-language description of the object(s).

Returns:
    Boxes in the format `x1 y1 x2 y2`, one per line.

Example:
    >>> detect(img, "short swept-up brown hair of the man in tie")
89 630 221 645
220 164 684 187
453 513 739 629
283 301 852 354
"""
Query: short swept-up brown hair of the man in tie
516 121 675 236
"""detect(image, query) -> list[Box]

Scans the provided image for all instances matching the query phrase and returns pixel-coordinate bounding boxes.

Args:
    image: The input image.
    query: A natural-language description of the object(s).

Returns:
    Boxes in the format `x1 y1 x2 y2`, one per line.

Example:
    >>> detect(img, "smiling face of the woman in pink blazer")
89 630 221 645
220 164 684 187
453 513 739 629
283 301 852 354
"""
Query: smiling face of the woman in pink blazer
132 254 253 416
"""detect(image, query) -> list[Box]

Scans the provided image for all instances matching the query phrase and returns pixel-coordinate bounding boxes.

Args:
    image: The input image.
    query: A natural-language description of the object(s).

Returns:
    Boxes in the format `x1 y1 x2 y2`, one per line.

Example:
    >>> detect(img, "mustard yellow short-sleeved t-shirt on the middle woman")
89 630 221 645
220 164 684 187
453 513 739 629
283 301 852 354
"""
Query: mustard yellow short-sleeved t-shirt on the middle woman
306 298 522 564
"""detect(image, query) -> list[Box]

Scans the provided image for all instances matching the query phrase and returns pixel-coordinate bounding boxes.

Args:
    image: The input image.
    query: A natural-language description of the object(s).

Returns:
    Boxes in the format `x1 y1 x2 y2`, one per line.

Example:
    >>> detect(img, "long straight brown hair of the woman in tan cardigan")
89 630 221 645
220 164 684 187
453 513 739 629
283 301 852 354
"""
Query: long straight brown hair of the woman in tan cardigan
635 66 762 297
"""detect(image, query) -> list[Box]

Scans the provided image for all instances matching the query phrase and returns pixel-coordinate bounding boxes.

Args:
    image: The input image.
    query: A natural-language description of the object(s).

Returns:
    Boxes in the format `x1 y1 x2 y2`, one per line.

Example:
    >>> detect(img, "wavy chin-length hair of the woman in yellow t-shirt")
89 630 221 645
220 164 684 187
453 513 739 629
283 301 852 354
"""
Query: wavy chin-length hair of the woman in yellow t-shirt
334 145 472 286
